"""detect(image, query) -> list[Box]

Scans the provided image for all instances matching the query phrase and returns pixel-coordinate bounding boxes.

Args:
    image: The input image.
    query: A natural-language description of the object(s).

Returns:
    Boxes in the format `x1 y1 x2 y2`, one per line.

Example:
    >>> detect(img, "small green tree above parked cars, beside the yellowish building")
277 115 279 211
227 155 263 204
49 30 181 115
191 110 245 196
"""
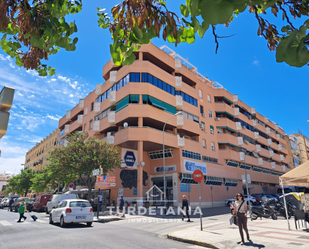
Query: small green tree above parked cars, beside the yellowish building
7 169 35 196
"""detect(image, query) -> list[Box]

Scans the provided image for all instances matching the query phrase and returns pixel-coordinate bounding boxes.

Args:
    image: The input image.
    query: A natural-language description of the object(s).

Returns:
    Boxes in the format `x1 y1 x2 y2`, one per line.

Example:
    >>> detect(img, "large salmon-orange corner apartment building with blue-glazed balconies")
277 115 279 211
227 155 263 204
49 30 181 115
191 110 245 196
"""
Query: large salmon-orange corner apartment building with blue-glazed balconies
58 44 289 206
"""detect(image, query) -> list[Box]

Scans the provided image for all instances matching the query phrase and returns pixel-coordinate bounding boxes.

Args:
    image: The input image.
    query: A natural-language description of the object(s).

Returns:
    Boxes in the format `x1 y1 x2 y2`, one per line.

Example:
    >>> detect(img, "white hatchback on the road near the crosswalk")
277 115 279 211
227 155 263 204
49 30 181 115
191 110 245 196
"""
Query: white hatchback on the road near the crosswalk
49 199 93 227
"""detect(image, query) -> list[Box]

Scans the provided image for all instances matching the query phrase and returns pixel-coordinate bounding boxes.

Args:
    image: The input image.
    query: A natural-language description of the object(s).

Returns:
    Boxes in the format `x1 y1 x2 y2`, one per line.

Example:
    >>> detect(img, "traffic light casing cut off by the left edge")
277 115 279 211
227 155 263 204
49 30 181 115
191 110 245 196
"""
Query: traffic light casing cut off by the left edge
0 86 15 138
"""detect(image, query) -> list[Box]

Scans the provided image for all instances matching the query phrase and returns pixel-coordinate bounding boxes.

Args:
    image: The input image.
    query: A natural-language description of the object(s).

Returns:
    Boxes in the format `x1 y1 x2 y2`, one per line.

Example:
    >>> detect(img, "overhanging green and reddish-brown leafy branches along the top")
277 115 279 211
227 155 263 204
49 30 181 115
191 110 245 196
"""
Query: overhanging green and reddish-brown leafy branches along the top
0 0 309 76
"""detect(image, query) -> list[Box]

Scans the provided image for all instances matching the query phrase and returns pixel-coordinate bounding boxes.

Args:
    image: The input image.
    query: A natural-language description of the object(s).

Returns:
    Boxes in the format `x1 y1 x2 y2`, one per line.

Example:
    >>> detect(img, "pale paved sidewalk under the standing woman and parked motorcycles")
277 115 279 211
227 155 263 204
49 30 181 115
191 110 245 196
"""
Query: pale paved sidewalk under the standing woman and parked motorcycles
167 214 309 249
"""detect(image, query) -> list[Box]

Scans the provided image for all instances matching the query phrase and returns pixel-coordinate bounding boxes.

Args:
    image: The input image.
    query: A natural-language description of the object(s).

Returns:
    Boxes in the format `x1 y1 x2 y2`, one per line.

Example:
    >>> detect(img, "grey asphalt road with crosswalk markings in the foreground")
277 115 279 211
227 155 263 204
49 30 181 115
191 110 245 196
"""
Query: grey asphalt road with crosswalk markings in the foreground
0 207 227 249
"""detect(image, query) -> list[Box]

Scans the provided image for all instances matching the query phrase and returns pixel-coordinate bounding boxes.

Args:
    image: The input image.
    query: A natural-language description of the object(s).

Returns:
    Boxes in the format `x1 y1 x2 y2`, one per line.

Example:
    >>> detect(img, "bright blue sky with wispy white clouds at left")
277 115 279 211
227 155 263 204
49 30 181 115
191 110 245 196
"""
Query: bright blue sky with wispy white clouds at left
0 0 309 173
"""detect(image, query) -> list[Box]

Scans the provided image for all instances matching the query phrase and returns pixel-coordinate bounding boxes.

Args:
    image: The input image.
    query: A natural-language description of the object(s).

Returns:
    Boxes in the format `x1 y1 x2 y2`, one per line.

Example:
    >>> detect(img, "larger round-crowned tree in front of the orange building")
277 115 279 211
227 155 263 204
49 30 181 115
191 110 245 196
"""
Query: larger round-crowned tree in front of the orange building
47 132 121 200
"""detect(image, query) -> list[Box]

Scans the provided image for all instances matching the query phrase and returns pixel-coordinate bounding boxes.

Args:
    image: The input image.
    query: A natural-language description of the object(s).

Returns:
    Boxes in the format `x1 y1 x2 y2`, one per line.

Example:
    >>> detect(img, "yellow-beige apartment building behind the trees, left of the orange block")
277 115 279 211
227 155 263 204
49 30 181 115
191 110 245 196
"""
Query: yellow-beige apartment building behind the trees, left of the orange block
24 129 60 171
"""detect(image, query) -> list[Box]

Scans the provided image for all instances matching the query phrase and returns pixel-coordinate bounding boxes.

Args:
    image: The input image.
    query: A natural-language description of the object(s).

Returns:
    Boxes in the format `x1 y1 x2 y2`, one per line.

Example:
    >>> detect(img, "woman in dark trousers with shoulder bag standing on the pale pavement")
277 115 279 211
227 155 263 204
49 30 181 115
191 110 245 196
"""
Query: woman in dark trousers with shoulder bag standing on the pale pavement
232 193 250 245
